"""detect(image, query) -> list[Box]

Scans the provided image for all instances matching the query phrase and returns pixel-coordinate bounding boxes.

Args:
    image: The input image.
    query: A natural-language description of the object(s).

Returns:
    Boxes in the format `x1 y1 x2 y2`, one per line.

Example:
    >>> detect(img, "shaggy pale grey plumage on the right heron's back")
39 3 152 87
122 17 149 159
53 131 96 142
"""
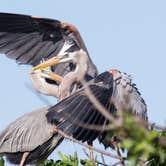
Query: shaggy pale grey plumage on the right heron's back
109 70 148 120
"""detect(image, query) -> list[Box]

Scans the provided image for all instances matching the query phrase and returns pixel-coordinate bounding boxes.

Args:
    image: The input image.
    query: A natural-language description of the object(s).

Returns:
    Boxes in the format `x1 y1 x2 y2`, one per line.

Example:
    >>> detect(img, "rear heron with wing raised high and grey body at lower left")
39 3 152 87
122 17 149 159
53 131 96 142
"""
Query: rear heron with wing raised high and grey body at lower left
0 13 97 165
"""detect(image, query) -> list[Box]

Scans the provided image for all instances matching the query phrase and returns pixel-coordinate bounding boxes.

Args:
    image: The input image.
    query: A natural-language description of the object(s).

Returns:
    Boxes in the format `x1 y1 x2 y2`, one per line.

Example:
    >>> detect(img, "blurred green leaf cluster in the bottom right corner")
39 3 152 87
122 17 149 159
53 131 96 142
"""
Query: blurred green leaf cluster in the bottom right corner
107 114 166 166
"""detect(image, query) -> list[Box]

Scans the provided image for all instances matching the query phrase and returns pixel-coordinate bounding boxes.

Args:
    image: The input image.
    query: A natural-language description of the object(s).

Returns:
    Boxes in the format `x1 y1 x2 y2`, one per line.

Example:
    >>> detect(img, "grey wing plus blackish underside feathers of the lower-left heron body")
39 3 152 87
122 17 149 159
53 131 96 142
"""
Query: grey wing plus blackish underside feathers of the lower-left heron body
0 108 63 164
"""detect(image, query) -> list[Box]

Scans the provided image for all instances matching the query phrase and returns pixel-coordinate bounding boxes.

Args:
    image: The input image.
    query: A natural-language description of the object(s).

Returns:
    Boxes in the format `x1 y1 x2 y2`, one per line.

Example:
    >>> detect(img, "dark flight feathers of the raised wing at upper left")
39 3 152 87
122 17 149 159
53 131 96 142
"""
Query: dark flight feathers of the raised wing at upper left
0 13 65 65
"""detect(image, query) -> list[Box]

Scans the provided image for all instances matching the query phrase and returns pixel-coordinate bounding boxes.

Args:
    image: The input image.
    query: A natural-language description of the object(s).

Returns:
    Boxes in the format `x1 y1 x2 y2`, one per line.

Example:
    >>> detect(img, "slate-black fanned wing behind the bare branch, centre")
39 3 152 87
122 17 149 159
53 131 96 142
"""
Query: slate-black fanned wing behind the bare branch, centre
46 85 111 142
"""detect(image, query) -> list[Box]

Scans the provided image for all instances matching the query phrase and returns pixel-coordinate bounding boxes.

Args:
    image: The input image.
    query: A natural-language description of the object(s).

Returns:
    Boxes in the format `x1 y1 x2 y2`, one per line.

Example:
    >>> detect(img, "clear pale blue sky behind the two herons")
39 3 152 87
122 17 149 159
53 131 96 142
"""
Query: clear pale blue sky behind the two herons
0 0 166 165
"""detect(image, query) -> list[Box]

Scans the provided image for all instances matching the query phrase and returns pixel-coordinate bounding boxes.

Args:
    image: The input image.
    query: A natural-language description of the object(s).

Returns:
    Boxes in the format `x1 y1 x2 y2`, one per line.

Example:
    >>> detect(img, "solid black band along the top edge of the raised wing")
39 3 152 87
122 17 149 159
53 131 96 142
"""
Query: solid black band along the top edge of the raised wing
0 13 60 33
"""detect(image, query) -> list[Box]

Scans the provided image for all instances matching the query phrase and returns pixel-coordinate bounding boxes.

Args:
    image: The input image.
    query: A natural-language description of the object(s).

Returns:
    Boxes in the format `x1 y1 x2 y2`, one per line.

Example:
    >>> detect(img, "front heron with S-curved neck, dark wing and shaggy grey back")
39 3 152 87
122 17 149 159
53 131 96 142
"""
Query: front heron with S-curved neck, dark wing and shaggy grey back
34 49 148 146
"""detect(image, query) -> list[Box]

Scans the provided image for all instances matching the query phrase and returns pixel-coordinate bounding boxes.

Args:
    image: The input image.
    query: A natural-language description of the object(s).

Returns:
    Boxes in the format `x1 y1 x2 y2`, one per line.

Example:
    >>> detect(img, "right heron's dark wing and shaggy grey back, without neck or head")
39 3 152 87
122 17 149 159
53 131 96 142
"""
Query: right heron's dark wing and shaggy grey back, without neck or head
47 70 147 141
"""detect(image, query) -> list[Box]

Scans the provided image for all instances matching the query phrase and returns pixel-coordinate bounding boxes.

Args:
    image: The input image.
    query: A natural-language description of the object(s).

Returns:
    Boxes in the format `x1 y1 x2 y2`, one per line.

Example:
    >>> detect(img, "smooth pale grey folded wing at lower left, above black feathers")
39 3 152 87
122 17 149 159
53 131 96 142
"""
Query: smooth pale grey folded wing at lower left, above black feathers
0 108 52 153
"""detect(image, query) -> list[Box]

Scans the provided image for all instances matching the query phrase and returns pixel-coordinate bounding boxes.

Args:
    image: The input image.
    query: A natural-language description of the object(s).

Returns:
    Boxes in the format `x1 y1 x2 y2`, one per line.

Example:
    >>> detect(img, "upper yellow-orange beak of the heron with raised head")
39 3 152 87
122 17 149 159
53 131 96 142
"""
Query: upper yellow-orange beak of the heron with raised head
32 57 62 71
